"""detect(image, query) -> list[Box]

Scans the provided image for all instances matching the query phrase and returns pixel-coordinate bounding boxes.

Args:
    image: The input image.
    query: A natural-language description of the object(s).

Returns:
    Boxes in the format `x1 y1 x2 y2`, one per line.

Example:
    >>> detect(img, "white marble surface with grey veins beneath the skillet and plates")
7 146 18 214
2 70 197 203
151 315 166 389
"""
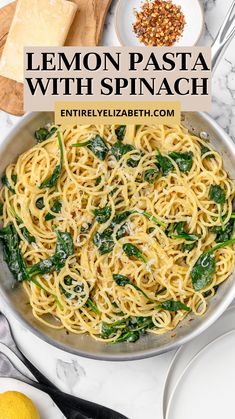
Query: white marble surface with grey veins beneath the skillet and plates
0 0 235 419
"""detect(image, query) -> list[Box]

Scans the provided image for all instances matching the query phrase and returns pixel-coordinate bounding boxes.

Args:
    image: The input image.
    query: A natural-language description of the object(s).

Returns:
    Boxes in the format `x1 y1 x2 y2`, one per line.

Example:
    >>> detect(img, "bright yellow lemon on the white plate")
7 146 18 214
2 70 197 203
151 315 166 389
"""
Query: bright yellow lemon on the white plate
0 391 40 419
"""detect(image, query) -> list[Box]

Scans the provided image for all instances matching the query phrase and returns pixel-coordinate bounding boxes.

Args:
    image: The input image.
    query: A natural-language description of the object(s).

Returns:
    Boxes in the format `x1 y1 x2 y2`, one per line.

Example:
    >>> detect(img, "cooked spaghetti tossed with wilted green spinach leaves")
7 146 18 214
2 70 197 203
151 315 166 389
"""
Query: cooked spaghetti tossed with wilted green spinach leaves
0 125 235 342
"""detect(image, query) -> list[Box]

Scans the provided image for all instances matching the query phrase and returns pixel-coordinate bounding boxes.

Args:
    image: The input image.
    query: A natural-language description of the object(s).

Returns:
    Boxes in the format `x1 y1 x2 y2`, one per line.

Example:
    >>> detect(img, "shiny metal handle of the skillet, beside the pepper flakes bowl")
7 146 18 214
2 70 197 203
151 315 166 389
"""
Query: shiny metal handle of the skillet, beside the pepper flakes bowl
211 0 235 72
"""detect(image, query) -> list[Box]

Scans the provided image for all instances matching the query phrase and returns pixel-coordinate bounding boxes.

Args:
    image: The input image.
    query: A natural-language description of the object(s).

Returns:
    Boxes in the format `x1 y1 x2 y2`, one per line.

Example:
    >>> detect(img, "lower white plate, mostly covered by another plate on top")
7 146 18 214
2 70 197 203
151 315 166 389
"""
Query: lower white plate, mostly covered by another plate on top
163 305 235 419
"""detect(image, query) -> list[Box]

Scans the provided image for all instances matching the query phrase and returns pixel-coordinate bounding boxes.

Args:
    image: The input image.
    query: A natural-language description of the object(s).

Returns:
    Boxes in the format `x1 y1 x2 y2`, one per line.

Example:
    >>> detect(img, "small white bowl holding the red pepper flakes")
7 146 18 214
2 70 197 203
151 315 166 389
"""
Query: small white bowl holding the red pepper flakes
115 0 204 47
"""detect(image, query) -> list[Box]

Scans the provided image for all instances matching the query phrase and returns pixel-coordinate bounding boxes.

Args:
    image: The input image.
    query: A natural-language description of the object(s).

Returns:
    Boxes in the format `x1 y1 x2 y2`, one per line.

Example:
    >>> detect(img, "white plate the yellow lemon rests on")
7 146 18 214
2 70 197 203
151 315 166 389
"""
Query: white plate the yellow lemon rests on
0 377 65 419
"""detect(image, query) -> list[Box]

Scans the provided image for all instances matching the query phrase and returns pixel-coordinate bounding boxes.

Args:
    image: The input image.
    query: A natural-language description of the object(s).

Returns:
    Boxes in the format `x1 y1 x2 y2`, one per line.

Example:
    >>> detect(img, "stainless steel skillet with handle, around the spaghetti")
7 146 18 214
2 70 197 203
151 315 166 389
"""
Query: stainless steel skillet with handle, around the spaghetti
0 1 235 361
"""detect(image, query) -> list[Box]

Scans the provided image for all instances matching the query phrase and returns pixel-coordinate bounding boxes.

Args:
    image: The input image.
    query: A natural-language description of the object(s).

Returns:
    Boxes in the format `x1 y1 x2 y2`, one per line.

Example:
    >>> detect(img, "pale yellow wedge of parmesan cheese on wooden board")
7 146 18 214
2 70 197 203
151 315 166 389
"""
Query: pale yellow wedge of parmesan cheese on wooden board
0 0 77 83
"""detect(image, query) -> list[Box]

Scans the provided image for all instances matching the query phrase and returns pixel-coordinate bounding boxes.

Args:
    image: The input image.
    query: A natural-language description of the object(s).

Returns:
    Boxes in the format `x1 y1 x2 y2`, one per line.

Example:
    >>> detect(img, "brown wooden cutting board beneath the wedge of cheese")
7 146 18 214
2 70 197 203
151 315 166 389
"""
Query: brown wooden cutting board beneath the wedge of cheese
0 0 112 116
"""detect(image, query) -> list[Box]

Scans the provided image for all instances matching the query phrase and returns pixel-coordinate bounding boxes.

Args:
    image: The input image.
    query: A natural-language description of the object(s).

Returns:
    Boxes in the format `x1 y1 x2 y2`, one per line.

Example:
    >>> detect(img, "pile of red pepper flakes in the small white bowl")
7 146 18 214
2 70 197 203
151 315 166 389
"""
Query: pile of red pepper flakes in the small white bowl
133 0 186 47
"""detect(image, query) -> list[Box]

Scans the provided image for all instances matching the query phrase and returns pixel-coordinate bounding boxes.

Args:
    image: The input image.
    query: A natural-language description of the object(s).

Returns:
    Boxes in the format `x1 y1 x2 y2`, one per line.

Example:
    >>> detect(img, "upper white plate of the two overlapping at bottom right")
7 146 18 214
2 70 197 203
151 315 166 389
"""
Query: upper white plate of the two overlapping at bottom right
166 330 235 419
